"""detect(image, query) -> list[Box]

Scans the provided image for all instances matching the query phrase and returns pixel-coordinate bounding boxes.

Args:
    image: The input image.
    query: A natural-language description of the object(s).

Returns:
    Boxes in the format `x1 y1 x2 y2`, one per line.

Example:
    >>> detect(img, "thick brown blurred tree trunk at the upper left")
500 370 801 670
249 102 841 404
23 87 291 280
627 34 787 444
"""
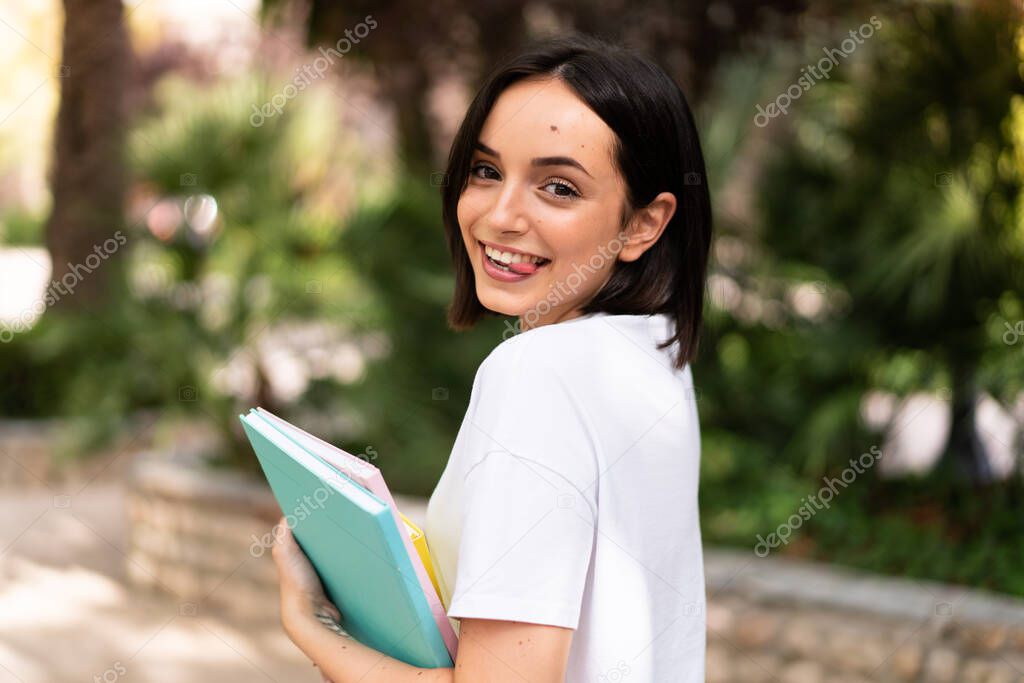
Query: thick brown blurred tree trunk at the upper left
46 0 131 311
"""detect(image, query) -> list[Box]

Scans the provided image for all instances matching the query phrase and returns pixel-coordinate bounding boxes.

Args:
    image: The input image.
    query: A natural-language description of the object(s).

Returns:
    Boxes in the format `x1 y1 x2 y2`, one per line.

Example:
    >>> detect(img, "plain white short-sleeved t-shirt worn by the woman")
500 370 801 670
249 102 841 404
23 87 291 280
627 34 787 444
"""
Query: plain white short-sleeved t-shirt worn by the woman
424 313 706 683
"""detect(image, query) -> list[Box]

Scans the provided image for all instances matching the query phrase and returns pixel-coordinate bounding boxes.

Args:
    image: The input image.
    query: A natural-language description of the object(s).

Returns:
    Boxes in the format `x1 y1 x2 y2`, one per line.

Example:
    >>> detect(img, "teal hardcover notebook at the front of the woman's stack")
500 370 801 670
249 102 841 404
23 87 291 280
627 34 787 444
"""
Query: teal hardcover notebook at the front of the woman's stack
239 410 453 669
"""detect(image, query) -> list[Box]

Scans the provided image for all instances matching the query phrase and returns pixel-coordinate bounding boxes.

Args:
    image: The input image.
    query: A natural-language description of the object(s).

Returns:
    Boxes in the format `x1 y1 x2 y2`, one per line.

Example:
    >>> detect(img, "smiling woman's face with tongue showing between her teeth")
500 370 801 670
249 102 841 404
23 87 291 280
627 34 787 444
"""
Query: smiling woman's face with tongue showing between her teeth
458 78 633 330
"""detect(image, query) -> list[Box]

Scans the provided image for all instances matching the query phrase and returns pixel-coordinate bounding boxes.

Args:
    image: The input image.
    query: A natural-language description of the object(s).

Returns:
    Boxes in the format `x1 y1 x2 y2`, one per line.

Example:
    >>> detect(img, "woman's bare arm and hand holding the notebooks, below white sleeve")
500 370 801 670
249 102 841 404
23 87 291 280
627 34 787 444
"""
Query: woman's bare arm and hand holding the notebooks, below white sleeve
271 518 573 683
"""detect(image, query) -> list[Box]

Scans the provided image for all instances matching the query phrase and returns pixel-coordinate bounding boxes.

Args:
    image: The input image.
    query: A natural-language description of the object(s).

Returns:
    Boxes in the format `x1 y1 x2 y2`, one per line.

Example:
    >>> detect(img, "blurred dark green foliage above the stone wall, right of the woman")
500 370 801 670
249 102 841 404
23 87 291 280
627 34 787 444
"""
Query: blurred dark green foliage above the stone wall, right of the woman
694 3 1024 594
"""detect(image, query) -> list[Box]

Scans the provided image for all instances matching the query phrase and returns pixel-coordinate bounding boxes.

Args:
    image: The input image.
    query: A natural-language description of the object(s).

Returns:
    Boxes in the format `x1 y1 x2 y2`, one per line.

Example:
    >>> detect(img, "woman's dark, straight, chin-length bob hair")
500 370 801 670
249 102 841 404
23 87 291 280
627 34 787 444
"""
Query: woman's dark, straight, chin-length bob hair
441 33 712 369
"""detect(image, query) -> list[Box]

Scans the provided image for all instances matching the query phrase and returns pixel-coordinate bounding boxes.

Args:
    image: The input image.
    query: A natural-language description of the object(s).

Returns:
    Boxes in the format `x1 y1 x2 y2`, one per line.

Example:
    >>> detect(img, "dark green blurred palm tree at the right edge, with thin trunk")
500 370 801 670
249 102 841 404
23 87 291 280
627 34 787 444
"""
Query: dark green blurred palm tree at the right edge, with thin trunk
763 3 1024 481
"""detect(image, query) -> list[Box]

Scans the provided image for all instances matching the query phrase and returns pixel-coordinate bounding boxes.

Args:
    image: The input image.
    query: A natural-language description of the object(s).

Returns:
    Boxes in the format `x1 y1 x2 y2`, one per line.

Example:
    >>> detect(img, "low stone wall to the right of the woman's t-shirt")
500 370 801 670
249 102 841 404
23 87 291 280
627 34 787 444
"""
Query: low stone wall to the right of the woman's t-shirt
706 550 1024 683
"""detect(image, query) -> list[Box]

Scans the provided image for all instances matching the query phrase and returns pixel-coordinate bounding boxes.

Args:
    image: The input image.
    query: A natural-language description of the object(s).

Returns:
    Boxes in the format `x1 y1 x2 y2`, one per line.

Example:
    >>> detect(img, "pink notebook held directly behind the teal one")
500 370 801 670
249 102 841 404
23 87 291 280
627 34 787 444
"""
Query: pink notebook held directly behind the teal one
256 408 459 661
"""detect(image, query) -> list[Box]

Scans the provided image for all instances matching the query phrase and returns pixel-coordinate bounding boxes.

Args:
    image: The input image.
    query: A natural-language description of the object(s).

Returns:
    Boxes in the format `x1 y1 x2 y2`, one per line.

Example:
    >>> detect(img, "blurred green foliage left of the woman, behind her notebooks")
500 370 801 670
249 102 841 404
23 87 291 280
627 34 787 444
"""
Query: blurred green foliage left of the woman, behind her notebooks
0 69 502 481
